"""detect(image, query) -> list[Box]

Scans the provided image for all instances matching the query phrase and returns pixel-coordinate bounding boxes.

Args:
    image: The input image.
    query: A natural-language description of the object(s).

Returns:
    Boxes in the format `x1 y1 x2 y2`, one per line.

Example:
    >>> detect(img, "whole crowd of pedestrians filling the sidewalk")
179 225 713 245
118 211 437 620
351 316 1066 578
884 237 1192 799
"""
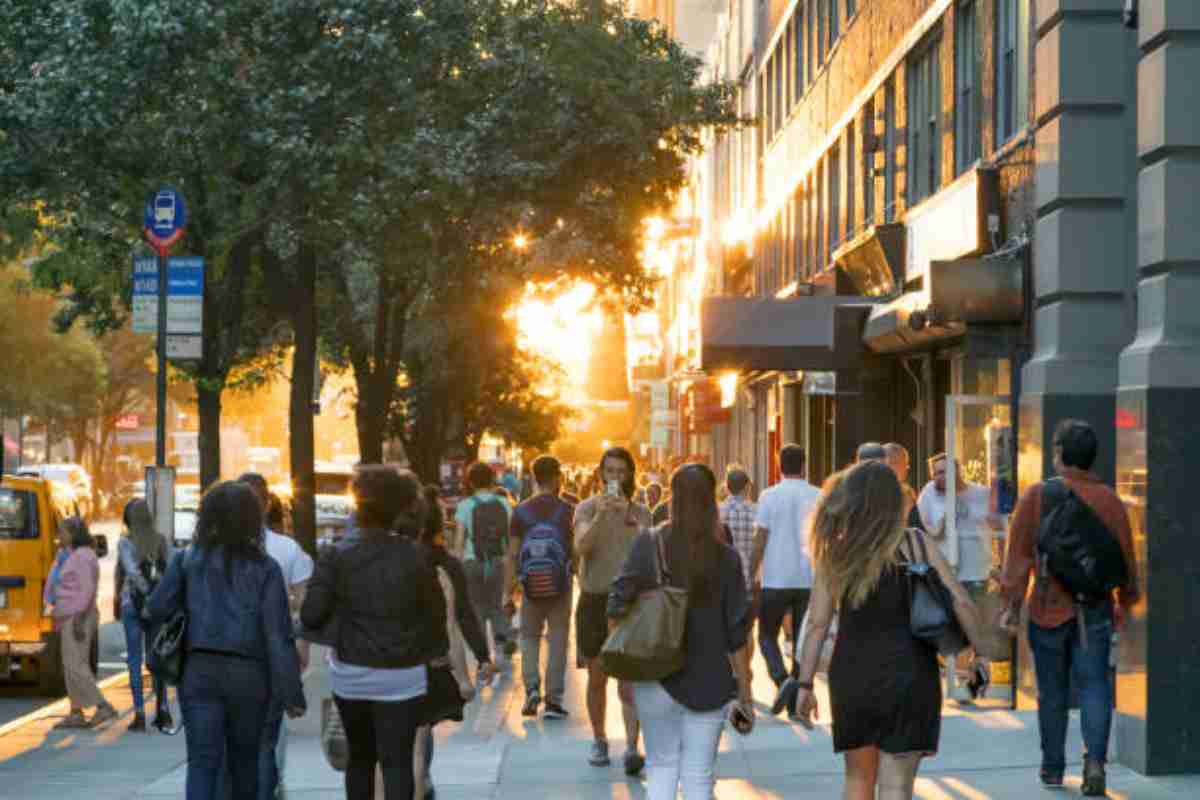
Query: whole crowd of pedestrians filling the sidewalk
32 410 1138 800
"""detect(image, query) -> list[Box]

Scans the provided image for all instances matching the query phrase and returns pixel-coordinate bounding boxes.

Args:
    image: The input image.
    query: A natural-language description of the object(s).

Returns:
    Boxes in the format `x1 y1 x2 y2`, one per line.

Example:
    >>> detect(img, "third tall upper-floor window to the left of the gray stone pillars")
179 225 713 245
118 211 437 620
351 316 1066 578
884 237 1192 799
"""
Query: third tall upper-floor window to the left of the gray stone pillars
907 36 942 205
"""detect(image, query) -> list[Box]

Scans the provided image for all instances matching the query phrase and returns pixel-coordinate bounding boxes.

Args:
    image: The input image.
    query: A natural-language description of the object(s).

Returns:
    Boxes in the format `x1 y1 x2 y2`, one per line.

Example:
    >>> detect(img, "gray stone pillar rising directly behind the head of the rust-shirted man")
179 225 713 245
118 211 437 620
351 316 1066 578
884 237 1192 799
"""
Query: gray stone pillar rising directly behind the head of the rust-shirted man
1020 0 1136 485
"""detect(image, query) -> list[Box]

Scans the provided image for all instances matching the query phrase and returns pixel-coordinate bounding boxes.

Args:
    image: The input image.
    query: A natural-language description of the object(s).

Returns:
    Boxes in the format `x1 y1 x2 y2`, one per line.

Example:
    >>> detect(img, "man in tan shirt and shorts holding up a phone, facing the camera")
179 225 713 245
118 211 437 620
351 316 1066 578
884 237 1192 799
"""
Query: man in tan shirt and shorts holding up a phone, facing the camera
575 447 650 775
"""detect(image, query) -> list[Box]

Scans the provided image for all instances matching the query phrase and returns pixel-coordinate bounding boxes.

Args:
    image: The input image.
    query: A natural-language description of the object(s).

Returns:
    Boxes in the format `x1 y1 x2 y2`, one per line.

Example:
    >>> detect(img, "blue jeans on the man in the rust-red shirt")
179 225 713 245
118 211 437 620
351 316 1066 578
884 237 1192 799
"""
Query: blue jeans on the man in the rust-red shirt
1030 603 1112 772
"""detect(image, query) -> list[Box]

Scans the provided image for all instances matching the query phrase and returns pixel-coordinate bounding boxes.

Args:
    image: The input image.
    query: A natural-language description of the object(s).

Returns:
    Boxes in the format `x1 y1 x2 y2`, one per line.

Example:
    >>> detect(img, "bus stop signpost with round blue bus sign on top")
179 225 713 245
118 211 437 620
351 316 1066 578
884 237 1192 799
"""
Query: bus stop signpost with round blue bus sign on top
141 186 188 542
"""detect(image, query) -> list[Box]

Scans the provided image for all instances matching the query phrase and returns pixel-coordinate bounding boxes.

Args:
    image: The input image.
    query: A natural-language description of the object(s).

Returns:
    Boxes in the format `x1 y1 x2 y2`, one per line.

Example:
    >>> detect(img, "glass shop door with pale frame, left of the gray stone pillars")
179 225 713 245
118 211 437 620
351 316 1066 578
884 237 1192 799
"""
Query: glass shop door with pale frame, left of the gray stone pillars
942 395 1016 698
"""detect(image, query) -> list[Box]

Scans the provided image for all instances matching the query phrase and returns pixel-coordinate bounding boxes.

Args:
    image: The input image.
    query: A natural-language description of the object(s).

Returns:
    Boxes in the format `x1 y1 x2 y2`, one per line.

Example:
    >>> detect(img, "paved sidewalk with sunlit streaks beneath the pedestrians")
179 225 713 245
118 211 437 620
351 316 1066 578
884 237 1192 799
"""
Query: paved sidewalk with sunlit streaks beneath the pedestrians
0 628 1200 800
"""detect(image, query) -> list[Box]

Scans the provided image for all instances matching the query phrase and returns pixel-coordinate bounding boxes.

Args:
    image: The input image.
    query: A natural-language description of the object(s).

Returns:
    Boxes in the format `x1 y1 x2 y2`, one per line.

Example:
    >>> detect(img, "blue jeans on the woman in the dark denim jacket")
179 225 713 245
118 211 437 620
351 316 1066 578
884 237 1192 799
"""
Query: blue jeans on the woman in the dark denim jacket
179 652 270 800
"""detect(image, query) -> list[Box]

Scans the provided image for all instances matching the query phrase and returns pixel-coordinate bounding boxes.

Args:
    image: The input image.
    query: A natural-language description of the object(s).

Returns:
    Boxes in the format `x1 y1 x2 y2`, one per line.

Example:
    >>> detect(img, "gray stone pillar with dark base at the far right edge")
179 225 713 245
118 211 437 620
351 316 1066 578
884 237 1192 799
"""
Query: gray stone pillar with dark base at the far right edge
1116 0 1200 775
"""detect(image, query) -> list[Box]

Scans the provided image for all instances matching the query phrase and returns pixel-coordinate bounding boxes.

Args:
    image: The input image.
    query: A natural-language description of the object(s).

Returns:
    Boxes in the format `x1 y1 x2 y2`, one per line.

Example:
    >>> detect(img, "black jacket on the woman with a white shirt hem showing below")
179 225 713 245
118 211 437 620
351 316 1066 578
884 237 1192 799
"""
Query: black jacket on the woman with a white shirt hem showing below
300 529 450 669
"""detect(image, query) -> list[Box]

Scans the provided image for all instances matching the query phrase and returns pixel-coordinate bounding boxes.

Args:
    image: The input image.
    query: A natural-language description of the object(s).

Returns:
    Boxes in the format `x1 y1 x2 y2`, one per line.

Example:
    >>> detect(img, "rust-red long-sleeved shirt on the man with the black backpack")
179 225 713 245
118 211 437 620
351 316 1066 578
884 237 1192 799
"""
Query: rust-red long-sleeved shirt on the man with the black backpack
1001 467 1138 627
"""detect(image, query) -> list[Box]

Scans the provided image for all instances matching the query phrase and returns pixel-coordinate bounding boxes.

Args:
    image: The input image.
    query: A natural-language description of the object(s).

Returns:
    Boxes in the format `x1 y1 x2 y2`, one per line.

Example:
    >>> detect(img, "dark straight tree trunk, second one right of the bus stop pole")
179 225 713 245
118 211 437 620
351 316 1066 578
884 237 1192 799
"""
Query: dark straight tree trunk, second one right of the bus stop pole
288 247 317 555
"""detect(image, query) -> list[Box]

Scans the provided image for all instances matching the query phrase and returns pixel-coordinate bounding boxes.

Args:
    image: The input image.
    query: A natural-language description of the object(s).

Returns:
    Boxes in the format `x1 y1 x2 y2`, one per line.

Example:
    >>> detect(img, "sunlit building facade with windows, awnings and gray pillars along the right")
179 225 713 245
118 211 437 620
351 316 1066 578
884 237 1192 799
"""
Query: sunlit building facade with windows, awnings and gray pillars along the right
655 0 1200 772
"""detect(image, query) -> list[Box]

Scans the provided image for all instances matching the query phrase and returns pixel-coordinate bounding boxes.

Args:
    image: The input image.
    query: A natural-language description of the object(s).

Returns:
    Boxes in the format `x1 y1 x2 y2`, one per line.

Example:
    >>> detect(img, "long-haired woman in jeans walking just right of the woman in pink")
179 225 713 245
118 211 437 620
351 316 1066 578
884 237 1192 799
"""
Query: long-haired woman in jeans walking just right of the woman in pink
113 498 175 730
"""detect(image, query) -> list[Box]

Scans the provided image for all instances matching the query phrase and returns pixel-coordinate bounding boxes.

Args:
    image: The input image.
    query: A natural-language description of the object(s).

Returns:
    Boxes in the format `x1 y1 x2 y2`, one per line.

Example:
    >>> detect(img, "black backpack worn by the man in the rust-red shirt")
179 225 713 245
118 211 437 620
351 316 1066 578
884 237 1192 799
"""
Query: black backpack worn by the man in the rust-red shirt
1038 479 1129 604
